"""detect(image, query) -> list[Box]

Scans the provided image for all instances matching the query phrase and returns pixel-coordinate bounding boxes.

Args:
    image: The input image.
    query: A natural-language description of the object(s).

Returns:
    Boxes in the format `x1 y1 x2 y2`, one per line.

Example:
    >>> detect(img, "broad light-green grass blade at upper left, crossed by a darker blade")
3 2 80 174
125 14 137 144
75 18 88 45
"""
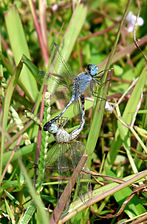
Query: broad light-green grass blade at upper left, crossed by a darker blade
5 6 38 102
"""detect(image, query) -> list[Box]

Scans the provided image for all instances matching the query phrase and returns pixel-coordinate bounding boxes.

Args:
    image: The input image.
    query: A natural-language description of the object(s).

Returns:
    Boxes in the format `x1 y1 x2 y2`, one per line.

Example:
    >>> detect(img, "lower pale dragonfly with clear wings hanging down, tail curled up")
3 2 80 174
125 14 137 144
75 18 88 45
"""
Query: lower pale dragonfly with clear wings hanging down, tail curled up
47 95 85 204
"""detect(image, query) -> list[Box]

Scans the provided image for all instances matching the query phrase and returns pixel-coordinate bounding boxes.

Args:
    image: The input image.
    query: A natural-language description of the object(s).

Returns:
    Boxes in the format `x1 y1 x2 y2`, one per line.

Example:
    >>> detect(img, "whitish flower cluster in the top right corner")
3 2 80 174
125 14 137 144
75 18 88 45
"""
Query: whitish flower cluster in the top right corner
126 12 144 33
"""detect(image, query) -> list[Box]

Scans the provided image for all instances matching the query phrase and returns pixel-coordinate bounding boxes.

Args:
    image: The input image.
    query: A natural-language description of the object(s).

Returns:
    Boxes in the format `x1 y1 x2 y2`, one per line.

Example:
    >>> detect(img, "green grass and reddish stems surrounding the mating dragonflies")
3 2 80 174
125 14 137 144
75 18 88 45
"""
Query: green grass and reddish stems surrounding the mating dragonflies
0 0 147 224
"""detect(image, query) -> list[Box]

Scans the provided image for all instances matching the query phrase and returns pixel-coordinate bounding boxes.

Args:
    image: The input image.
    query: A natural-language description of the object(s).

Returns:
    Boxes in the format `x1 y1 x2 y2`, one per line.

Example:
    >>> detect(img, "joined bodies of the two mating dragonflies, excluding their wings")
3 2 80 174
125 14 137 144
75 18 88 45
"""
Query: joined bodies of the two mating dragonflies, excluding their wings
43 64 103 143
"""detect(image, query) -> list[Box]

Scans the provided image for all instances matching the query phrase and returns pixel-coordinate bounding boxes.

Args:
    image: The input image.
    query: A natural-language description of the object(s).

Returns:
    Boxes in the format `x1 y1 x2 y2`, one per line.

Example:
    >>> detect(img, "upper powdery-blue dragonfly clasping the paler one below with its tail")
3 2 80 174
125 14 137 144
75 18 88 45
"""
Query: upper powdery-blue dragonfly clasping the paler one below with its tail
43 64 104 131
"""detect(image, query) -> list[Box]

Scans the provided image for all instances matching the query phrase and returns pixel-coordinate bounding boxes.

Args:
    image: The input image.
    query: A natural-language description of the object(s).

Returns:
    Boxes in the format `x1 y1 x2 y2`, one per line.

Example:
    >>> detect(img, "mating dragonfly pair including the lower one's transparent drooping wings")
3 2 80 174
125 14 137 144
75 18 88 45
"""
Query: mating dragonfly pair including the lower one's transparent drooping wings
43 45 104 206
